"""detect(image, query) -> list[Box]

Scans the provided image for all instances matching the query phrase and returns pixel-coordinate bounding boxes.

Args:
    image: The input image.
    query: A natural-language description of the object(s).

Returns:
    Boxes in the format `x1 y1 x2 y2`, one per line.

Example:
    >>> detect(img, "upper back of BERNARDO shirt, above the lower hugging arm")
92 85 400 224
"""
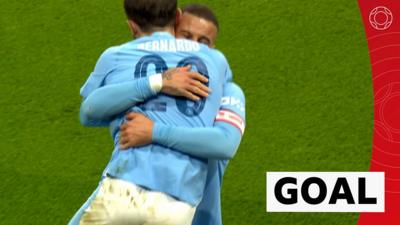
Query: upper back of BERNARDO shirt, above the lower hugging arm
105 33 225 126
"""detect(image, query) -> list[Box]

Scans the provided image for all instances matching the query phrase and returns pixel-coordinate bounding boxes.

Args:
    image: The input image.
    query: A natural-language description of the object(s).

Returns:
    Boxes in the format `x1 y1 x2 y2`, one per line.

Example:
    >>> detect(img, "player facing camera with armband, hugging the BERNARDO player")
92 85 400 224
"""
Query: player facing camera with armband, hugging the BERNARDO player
69 4 244 225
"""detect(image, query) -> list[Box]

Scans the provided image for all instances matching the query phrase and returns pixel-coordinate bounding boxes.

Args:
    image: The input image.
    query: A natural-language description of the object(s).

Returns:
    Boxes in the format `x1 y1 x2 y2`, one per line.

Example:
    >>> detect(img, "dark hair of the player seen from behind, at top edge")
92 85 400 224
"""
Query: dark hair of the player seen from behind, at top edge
124 0 178 32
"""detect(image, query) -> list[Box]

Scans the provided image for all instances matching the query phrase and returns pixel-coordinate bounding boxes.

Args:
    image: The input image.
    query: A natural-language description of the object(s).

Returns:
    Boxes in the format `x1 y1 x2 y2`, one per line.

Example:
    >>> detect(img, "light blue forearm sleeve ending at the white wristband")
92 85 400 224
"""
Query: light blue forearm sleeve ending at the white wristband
80 77 156 126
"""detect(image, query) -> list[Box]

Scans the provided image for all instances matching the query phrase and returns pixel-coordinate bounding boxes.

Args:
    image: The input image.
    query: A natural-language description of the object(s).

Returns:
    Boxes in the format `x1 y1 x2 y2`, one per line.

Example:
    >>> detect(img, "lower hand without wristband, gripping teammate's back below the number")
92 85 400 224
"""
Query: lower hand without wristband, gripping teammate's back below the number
119 113 154 150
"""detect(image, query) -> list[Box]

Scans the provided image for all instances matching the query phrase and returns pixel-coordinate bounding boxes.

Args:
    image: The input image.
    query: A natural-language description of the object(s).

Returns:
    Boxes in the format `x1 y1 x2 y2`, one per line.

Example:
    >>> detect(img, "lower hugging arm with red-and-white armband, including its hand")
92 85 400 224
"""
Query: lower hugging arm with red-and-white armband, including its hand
120 83 245 159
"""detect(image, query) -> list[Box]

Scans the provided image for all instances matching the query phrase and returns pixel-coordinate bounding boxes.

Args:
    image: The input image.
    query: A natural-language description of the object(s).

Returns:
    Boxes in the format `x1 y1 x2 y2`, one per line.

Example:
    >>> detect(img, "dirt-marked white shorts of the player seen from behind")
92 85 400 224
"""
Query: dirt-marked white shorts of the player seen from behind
79 178 196 225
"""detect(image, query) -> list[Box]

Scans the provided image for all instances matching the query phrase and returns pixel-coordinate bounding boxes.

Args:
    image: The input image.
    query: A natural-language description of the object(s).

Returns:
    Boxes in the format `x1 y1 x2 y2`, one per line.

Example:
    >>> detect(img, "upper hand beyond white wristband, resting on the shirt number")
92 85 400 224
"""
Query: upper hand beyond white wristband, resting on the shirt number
161 66 211 101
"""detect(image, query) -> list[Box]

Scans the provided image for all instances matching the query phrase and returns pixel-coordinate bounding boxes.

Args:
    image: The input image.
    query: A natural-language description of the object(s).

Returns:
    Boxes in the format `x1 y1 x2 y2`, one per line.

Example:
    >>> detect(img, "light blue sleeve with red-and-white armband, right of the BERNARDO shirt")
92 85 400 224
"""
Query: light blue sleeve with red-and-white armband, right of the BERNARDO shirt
153 83 245 160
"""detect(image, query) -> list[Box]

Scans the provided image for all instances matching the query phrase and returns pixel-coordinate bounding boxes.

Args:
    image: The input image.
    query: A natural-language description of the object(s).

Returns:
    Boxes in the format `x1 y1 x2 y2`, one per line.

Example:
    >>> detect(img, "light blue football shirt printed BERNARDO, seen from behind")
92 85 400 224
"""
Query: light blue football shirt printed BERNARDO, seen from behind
81 32 232 205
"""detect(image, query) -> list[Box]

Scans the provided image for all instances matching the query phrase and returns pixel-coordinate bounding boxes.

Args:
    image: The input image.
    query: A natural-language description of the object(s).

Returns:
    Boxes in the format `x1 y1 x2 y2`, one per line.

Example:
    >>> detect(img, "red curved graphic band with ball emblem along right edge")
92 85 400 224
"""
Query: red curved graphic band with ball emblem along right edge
358 0 400 225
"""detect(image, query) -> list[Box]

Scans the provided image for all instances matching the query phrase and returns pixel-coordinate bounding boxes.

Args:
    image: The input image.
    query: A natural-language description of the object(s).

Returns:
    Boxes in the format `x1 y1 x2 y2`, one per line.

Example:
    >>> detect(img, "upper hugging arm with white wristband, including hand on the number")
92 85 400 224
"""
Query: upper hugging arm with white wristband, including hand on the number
80 66 210 126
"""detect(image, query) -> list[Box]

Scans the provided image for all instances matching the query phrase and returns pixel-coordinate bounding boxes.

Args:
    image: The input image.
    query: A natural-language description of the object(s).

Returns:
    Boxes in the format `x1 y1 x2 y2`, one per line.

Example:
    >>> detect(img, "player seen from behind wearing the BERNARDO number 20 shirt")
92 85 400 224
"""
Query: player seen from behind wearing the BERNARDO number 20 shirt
70 0 231 224
